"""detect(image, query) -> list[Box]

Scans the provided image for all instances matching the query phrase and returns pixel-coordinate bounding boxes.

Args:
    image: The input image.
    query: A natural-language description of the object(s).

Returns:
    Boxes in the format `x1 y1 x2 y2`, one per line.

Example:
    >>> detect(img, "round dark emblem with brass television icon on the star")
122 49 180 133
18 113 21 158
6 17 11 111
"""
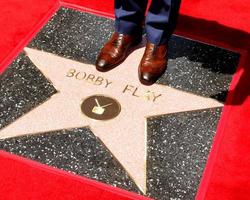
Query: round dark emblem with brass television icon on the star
81 95 121 120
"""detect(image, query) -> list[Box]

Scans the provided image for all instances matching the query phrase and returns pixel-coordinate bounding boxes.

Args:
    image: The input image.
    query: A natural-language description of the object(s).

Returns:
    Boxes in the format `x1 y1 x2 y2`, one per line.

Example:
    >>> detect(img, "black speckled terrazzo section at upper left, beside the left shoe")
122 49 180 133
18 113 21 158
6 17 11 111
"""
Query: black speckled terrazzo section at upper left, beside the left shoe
28 8 113 64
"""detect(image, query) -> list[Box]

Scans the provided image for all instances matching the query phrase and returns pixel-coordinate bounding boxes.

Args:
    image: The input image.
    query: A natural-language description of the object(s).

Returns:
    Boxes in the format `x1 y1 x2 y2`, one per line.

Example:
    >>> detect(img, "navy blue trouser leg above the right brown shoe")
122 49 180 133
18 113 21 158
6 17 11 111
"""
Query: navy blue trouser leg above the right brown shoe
145 0 181 45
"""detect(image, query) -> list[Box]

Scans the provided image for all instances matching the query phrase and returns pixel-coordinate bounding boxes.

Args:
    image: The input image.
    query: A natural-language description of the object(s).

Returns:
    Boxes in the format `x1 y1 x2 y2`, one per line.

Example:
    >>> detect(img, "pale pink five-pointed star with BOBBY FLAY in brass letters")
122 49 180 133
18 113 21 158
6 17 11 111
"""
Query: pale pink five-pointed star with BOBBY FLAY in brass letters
0 48 222 193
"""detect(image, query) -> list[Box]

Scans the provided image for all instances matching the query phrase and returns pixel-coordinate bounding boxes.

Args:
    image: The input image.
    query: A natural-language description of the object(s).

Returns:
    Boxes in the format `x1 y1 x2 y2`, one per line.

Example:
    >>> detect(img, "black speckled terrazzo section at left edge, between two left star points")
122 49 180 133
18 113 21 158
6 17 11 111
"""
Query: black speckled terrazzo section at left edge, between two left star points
0 53 56 129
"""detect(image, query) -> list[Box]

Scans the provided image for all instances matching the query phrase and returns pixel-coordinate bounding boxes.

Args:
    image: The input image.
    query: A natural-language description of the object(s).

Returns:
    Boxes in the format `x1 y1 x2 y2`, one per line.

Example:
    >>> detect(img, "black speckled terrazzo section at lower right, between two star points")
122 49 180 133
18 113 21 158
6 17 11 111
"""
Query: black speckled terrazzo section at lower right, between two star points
147 108 221 200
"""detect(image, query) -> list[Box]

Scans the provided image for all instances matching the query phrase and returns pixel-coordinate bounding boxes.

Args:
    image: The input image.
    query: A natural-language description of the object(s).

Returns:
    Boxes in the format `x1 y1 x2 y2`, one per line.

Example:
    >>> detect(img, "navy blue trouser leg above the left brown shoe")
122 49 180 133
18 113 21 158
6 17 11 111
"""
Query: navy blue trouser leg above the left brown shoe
115 0 148 34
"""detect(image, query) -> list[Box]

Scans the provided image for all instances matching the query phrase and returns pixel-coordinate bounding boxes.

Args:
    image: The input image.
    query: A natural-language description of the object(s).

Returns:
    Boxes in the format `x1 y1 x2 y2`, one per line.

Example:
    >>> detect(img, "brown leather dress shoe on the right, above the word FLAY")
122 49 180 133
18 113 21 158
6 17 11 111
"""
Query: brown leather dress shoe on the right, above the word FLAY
138 42 168 85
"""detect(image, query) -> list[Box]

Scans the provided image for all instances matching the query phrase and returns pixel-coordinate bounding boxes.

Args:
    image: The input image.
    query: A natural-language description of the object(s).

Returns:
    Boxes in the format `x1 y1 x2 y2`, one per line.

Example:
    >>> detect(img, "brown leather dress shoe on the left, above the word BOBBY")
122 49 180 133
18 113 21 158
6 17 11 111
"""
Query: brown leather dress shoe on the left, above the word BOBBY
96 32 142 72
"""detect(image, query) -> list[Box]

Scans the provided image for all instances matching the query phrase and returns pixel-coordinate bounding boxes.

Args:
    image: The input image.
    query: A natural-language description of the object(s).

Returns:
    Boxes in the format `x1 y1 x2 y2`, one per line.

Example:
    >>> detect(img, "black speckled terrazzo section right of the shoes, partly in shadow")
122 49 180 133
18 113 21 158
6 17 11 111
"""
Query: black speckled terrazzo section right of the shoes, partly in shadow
161 37 239 102
